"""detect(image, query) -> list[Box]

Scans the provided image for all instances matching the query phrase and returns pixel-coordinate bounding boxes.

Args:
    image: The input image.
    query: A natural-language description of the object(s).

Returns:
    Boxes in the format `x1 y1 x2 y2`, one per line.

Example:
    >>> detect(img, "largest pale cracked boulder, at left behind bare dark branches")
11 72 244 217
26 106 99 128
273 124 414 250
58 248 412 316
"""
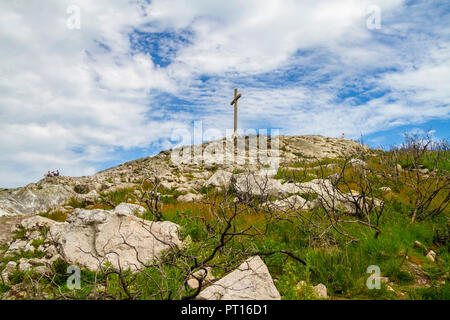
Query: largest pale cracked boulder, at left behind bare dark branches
49 209 182 271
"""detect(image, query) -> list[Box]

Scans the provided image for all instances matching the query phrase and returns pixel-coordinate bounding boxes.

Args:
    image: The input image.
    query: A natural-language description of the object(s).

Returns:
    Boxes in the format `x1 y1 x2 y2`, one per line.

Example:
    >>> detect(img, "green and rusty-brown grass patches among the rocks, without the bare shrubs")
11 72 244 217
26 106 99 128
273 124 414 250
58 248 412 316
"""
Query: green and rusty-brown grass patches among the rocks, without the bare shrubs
0 143 450 300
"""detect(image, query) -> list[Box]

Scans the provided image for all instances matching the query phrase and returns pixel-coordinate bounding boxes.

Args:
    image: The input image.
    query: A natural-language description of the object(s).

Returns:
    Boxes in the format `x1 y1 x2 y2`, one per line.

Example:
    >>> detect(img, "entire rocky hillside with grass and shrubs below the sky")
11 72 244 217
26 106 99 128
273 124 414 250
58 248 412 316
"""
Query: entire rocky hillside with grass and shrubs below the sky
0 136 450 299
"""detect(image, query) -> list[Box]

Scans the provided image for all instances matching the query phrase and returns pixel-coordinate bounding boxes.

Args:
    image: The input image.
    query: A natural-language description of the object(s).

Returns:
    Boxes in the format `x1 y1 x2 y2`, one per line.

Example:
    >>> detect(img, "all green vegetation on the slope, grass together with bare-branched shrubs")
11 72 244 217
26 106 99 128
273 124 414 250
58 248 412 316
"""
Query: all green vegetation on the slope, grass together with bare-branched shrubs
0 134 450 300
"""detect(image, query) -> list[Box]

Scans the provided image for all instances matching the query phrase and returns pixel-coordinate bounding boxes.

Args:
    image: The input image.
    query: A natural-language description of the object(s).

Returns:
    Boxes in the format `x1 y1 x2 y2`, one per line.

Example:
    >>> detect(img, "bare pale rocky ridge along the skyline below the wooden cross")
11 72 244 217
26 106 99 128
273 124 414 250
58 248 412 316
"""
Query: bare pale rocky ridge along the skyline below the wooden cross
0 135 367 217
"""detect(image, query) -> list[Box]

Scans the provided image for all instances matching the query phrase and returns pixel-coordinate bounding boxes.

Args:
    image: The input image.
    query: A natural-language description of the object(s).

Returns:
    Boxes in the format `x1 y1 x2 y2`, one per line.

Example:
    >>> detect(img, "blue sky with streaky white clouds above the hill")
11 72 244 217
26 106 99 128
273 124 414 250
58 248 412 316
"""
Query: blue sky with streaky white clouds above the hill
0 0 450 188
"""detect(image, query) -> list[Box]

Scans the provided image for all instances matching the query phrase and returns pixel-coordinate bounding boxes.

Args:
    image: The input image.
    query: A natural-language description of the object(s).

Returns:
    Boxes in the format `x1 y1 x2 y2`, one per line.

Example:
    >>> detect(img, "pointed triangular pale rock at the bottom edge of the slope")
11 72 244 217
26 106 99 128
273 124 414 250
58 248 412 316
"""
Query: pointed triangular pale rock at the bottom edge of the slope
197 256 281 300
